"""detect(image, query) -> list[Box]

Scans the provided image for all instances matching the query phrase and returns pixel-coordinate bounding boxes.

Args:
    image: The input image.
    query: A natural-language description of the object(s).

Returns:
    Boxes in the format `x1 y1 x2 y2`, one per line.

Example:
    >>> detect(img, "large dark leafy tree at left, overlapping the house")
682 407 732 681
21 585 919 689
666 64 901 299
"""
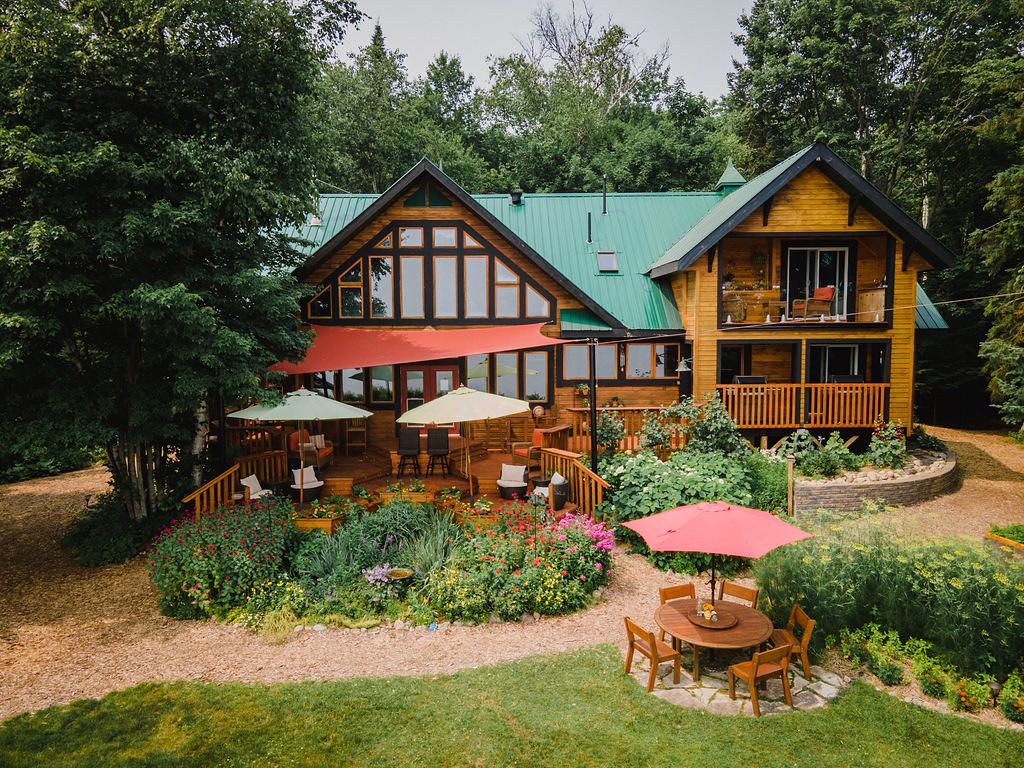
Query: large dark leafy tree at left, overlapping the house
0 0 357 519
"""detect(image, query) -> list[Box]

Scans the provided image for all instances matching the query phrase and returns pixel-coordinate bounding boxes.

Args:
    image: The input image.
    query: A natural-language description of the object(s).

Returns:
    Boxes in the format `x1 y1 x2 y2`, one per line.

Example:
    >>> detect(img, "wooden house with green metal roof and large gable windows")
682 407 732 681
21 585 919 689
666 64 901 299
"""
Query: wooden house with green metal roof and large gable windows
272 143 952 444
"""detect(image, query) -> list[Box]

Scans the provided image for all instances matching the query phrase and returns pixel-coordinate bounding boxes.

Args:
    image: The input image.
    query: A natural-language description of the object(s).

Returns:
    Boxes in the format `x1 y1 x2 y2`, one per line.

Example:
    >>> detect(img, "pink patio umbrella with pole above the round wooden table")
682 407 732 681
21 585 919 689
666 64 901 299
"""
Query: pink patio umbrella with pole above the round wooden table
623 502 813 604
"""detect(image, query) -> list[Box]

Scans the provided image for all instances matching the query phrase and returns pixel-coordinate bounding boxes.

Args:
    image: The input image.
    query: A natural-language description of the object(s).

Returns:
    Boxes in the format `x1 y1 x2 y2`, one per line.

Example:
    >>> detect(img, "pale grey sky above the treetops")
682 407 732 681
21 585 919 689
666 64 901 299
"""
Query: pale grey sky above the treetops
341 0 751 98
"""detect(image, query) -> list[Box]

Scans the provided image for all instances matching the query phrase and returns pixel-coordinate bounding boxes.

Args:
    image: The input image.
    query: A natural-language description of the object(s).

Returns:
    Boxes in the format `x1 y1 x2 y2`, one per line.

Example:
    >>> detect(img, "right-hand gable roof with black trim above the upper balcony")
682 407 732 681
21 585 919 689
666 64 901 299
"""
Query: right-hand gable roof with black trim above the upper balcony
648 142 953 278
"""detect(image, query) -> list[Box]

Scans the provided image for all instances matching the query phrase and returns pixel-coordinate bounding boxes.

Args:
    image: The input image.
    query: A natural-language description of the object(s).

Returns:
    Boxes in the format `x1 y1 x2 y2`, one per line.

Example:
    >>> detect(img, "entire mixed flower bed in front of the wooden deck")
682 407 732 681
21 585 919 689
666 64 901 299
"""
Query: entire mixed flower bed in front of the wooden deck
147 494 613 636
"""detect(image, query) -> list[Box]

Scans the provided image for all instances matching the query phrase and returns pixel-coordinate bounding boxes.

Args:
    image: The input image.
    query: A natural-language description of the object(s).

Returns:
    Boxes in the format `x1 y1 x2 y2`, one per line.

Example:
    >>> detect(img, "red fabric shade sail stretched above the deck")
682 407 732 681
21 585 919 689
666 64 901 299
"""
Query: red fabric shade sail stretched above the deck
270 323 566 374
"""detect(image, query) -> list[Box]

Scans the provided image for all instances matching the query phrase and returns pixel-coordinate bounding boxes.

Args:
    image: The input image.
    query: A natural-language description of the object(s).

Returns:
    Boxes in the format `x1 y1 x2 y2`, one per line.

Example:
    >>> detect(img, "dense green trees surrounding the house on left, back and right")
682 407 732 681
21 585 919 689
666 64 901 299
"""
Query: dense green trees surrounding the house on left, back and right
0 0 1024 505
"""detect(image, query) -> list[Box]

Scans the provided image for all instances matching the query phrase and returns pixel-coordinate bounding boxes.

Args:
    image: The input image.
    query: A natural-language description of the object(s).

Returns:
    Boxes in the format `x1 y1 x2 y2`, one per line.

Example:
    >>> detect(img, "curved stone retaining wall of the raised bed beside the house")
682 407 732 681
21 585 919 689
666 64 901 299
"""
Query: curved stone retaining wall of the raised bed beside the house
794 452 959 515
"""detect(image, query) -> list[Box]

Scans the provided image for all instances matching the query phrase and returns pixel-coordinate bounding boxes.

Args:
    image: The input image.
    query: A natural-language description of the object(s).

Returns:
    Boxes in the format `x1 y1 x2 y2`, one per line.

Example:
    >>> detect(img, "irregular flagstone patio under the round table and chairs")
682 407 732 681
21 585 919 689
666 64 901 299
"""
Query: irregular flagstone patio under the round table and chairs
633 650 850 715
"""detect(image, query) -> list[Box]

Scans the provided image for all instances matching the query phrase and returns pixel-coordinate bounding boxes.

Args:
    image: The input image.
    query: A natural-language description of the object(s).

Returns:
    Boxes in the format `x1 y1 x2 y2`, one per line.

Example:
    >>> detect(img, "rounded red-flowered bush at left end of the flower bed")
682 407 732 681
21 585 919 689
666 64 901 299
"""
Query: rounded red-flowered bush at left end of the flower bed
147 496 298 618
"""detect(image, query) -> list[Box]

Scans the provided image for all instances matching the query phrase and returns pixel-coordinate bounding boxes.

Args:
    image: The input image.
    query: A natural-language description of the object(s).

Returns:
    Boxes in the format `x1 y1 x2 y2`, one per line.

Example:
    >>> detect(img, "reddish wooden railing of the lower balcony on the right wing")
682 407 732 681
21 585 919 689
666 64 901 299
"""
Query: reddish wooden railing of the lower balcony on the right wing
718 384 889 429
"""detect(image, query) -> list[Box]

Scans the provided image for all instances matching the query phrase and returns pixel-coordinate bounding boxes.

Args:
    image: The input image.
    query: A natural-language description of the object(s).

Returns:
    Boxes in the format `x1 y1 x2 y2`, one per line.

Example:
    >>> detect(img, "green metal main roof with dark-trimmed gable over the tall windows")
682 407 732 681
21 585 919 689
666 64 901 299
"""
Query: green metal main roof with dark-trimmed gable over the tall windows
292 160 721 331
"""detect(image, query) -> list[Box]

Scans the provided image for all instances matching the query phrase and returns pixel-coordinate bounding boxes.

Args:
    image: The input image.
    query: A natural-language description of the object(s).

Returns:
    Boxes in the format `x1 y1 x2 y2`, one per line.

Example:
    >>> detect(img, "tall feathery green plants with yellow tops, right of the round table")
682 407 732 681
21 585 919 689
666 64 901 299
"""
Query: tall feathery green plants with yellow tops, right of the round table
754 530 1024 678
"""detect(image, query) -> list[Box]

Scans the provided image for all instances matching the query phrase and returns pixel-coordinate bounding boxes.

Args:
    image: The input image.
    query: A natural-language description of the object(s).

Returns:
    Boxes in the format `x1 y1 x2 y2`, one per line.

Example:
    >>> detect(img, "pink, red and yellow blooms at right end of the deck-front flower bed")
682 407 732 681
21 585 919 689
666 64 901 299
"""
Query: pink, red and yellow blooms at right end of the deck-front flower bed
427 504 614 622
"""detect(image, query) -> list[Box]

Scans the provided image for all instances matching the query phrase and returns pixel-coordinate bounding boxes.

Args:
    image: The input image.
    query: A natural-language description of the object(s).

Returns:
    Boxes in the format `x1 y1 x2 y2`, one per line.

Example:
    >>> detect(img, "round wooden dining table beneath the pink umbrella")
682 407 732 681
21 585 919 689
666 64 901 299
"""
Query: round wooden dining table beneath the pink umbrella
654 599 774 681
